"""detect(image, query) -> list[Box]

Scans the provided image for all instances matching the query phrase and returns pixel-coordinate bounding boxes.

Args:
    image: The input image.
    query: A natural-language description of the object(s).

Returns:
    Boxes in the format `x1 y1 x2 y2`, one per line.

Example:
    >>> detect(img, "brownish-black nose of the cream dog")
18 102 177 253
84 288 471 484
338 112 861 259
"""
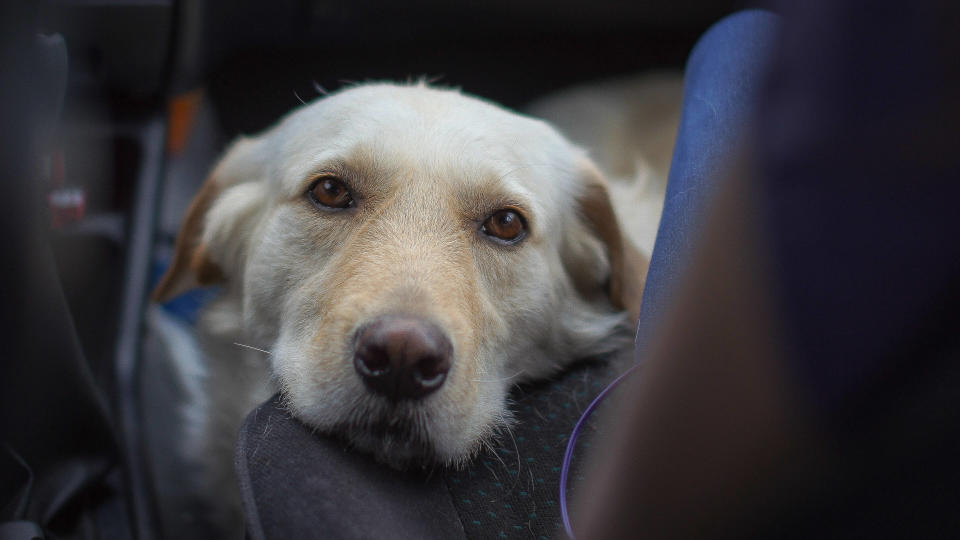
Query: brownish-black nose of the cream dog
353 315 453 401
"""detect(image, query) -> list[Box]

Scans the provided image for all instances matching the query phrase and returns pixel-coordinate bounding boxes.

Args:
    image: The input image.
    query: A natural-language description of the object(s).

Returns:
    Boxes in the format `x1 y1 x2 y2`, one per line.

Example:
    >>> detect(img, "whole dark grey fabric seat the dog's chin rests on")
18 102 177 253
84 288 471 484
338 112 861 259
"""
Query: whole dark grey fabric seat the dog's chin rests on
236 359 628 540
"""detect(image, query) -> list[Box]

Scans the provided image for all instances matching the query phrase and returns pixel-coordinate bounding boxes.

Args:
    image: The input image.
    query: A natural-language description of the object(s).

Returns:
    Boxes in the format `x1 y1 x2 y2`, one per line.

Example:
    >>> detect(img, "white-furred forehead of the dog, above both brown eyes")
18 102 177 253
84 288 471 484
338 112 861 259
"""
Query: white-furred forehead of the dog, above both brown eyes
270 84 580 203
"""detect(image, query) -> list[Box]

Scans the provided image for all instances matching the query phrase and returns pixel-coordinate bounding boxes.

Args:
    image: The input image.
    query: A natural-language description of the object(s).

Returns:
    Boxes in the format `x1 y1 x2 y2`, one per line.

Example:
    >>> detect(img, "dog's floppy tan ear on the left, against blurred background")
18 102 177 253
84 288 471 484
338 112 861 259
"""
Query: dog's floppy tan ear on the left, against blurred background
151 137 259 302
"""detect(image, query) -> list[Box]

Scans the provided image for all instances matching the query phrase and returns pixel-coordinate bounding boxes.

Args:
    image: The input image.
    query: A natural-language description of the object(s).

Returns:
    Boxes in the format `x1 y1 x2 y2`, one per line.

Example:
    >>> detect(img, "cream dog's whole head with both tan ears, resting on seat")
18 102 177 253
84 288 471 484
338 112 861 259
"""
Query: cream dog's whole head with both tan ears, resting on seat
157 84 645 466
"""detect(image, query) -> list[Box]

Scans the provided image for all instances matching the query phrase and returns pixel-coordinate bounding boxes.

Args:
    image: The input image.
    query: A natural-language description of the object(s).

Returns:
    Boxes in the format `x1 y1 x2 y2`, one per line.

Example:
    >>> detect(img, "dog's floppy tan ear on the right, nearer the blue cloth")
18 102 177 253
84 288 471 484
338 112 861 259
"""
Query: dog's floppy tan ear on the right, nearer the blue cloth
577 158 650 322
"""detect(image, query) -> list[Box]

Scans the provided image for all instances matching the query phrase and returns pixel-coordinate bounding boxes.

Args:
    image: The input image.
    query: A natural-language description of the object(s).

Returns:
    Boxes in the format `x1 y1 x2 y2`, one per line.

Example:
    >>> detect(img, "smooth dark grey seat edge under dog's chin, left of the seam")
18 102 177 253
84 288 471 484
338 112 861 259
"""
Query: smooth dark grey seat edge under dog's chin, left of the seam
237 397 464 540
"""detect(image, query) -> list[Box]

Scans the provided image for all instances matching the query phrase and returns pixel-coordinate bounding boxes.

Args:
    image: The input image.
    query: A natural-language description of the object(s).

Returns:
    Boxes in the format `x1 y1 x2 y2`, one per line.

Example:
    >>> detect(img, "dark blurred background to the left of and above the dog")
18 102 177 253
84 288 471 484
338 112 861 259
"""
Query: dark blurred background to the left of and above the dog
0 0 745 538
